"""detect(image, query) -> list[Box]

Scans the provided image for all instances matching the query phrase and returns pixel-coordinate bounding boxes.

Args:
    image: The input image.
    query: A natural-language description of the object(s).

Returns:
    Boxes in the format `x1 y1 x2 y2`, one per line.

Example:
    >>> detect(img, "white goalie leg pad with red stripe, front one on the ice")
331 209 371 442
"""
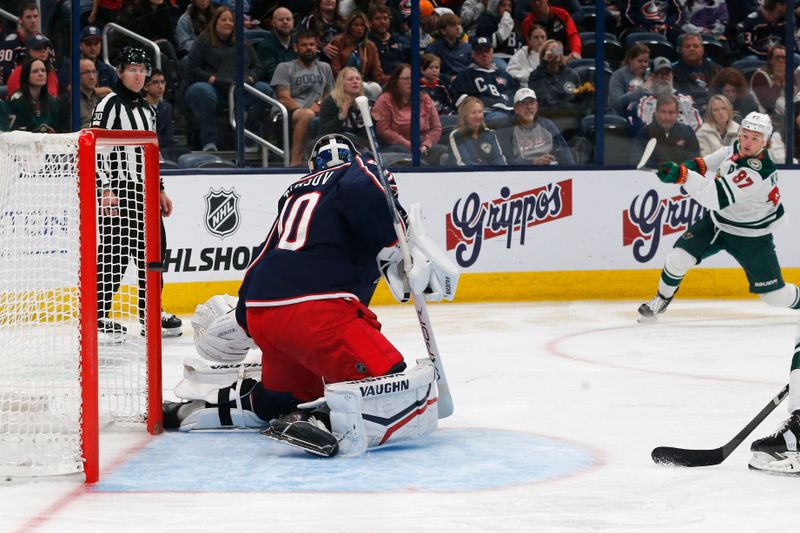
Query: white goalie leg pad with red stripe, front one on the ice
325 358 439 456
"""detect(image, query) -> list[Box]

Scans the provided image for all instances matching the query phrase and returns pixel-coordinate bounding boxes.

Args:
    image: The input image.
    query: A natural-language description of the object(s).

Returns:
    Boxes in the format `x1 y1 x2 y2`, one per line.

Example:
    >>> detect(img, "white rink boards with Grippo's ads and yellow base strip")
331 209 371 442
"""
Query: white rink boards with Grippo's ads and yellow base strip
156 168 800 312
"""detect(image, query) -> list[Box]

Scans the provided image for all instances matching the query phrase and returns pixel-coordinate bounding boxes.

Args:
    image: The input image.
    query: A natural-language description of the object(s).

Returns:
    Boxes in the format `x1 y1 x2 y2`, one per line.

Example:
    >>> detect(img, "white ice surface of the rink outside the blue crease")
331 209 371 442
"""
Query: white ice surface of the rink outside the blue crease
0 300 800 533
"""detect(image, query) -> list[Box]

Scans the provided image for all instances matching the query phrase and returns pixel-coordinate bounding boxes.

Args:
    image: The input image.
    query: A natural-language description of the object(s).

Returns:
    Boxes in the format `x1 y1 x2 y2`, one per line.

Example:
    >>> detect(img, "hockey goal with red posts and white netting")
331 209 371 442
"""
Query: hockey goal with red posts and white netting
0 130 161 482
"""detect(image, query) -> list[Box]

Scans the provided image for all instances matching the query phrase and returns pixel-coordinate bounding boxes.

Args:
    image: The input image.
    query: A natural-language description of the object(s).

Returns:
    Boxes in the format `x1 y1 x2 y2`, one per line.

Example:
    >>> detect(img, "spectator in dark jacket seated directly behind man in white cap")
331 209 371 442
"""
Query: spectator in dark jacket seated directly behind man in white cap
528 39 580 139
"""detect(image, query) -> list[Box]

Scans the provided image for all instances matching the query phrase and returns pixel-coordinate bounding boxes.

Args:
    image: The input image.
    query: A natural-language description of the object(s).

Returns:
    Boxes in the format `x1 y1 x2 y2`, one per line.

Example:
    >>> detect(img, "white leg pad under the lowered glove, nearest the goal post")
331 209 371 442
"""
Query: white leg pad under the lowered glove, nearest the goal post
174 358 261 402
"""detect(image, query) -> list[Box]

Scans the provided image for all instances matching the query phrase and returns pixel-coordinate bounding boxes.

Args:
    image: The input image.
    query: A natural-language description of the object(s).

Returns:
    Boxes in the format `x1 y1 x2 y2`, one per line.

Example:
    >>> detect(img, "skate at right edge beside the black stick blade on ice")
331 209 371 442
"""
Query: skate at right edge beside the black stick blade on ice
748 411 800 476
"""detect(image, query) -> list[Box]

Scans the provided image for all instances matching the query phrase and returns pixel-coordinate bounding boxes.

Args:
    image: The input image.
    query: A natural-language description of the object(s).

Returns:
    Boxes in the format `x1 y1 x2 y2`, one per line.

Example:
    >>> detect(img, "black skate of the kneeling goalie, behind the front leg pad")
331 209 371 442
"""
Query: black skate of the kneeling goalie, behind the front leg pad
261 409 339 457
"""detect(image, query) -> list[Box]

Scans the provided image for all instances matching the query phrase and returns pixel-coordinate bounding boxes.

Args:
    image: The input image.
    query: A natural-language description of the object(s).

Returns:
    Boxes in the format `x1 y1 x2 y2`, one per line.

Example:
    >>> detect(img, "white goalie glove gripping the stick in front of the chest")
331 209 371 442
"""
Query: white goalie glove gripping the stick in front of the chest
377 204 459 303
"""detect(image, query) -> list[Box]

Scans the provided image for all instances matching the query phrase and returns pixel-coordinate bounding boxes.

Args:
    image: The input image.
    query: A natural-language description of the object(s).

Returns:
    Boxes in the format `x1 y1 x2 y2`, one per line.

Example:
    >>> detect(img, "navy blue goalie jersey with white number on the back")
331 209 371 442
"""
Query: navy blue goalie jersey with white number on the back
236 156 404 327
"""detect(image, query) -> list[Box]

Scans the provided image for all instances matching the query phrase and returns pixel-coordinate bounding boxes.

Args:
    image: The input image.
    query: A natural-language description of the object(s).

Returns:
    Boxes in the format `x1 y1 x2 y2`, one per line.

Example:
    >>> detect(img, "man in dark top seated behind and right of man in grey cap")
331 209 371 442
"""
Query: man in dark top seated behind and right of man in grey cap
672 33 722 109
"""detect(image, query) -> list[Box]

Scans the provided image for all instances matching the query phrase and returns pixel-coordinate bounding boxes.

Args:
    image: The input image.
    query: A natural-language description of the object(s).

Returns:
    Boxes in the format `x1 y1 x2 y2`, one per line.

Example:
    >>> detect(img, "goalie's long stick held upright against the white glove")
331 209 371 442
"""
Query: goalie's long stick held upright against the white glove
356 96 453 418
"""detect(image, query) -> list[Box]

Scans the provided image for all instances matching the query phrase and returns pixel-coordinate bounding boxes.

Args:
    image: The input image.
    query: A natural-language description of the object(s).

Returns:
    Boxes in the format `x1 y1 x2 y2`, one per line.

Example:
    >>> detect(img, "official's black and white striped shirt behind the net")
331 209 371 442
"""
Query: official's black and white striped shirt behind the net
91 81 156 188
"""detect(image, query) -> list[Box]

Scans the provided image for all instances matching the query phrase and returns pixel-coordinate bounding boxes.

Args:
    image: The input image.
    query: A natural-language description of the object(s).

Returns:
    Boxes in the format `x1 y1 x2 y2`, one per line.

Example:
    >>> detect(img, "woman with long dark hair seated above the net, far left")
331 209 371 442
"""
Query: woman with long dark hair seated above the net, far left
8 58 58 133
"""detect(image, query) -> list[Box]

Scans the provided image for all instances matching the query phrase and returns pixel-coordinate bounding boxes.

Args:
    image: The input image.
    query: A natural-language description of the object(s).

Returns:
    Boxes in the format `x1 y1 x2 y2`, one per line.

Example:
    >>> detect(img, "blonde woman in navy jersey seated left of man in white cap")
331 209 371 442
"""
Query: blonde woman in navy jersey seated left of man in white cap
448 96 506 166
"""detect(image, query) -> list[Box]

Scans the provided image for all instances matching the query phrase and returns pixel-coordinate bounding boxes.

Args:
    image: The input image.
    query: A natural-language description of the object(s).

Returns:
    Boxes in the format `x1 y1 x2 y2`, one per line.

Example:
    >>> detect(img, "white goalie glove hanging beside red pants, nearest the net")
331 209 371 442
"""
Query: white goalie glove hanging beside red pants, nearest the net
192 294 254 364
